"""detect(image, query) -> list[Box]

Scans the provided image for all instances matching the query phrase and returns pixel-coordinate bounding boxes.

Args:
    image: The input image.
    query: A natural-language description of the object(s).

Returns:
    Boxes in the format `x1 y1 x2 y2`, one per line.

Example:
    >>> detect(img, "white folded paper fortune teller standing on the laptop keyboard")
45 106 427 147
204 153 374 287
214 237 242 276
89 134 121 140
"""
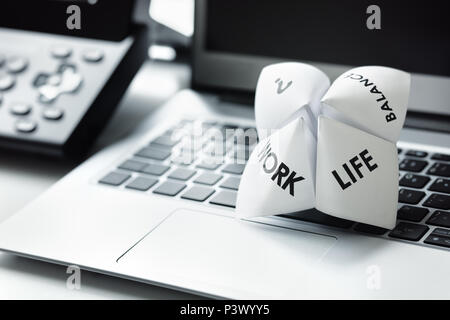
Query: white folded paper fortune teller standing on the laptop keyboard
236 62 410 229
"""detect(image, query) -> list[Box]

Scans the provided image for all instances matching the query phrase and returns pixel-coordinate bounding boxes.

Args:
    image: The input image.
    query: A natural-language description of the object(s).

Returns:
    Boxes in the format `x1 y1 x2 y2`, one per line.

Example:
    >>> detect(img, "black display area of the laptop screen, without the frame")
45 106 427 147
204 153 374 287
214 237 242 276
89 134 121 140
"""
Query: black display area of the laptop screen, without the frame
206 0 450 76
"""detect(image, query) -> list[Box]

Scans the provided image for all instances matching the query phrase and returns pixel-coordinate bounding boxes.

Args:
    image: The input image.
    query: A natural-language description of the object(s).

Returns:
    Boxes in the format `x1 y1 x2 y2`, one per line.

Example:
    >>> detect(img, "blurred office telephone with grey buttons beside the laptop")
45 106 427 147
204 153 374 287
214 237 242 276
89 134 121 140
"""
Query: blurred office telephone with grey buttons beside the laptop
0 0 148 158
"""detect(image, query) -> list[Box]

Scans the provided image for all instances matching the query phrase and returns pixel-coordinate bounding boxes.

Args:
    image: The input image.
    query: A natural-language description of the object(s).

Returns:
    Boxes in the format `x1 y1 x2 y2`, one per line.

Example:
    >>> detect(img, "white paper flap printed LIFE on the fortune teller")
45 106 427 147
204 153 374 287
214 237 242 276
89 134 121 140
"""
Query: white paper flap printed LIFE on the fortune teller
316 116 398 229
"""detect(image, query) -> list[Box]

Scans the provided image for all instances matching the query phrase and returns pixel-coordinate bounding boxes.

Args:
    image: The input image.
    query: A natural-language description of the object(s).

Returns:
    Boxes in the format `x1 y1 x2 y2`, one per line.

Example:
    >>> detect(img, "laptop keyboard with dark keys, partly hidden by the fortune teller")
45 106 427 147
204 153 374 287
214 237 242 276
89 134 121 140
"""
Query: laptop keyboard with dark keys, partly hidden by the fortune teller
99 120 450 251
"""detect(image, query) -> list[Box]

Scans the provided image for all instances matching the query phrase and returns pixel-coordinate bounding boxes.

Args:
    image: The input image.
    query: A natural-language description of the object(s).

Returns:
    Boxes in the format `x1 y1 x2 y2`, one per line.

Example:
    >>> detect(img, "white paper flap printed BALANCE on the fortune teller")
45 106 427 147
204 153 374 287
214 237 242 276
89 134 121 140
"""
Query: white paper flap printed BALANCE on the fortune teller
322 66 411 143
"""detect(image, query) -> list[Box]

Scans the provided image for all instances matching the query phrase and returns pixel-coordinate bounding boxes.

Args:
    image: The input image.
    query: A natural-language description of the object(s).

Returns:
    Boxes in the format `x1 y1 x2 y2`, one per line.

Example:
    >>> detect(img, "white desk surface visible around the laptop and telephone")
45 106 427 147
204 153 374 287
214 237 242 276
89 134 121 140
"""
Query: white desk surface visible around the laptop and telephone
0 62 197 299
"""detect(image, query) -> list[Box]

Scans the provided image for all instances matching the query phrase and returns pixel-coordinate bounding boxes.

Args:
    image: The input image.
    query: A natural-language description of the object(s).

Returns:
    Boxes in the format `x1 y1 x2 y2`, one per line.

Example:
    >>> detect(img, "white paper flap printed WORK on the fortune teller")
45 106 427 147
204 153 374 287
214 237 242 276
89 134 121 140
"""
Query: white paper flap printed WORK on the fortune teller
236 118 316 218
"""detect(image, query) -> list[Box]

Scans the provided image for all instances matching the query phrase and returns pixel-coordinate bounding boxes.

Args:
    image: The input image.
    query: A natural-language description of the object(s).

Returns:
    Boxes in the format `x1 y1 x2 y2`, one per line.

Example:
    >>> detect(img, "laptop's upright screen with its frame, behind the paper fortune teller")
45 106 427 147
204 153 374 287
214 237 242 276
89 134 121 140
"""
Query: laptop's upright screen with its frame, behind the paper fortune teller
192 0 450 116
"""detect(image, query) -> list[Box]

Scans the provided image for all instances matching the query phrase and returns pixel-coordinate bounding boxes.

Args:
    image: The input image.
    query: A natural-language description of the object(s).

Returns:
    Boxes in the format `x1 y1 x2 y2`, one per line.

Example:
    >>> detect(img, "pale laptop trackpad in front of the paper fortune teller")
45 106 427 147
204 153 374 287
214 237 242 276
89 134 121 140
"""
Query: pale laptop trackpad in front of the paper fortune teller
118 209 336 298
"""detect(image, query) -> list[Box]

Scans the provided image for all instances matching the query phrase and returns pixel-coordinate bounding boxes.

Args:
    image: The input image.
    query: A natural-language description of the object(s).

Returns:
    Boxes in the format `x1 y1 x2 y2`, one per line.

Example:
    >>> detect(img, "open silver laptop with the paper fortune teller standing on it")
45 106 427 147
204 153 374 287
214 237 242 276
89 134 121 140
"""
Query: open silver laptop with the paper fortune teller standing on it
0 0 450 299
